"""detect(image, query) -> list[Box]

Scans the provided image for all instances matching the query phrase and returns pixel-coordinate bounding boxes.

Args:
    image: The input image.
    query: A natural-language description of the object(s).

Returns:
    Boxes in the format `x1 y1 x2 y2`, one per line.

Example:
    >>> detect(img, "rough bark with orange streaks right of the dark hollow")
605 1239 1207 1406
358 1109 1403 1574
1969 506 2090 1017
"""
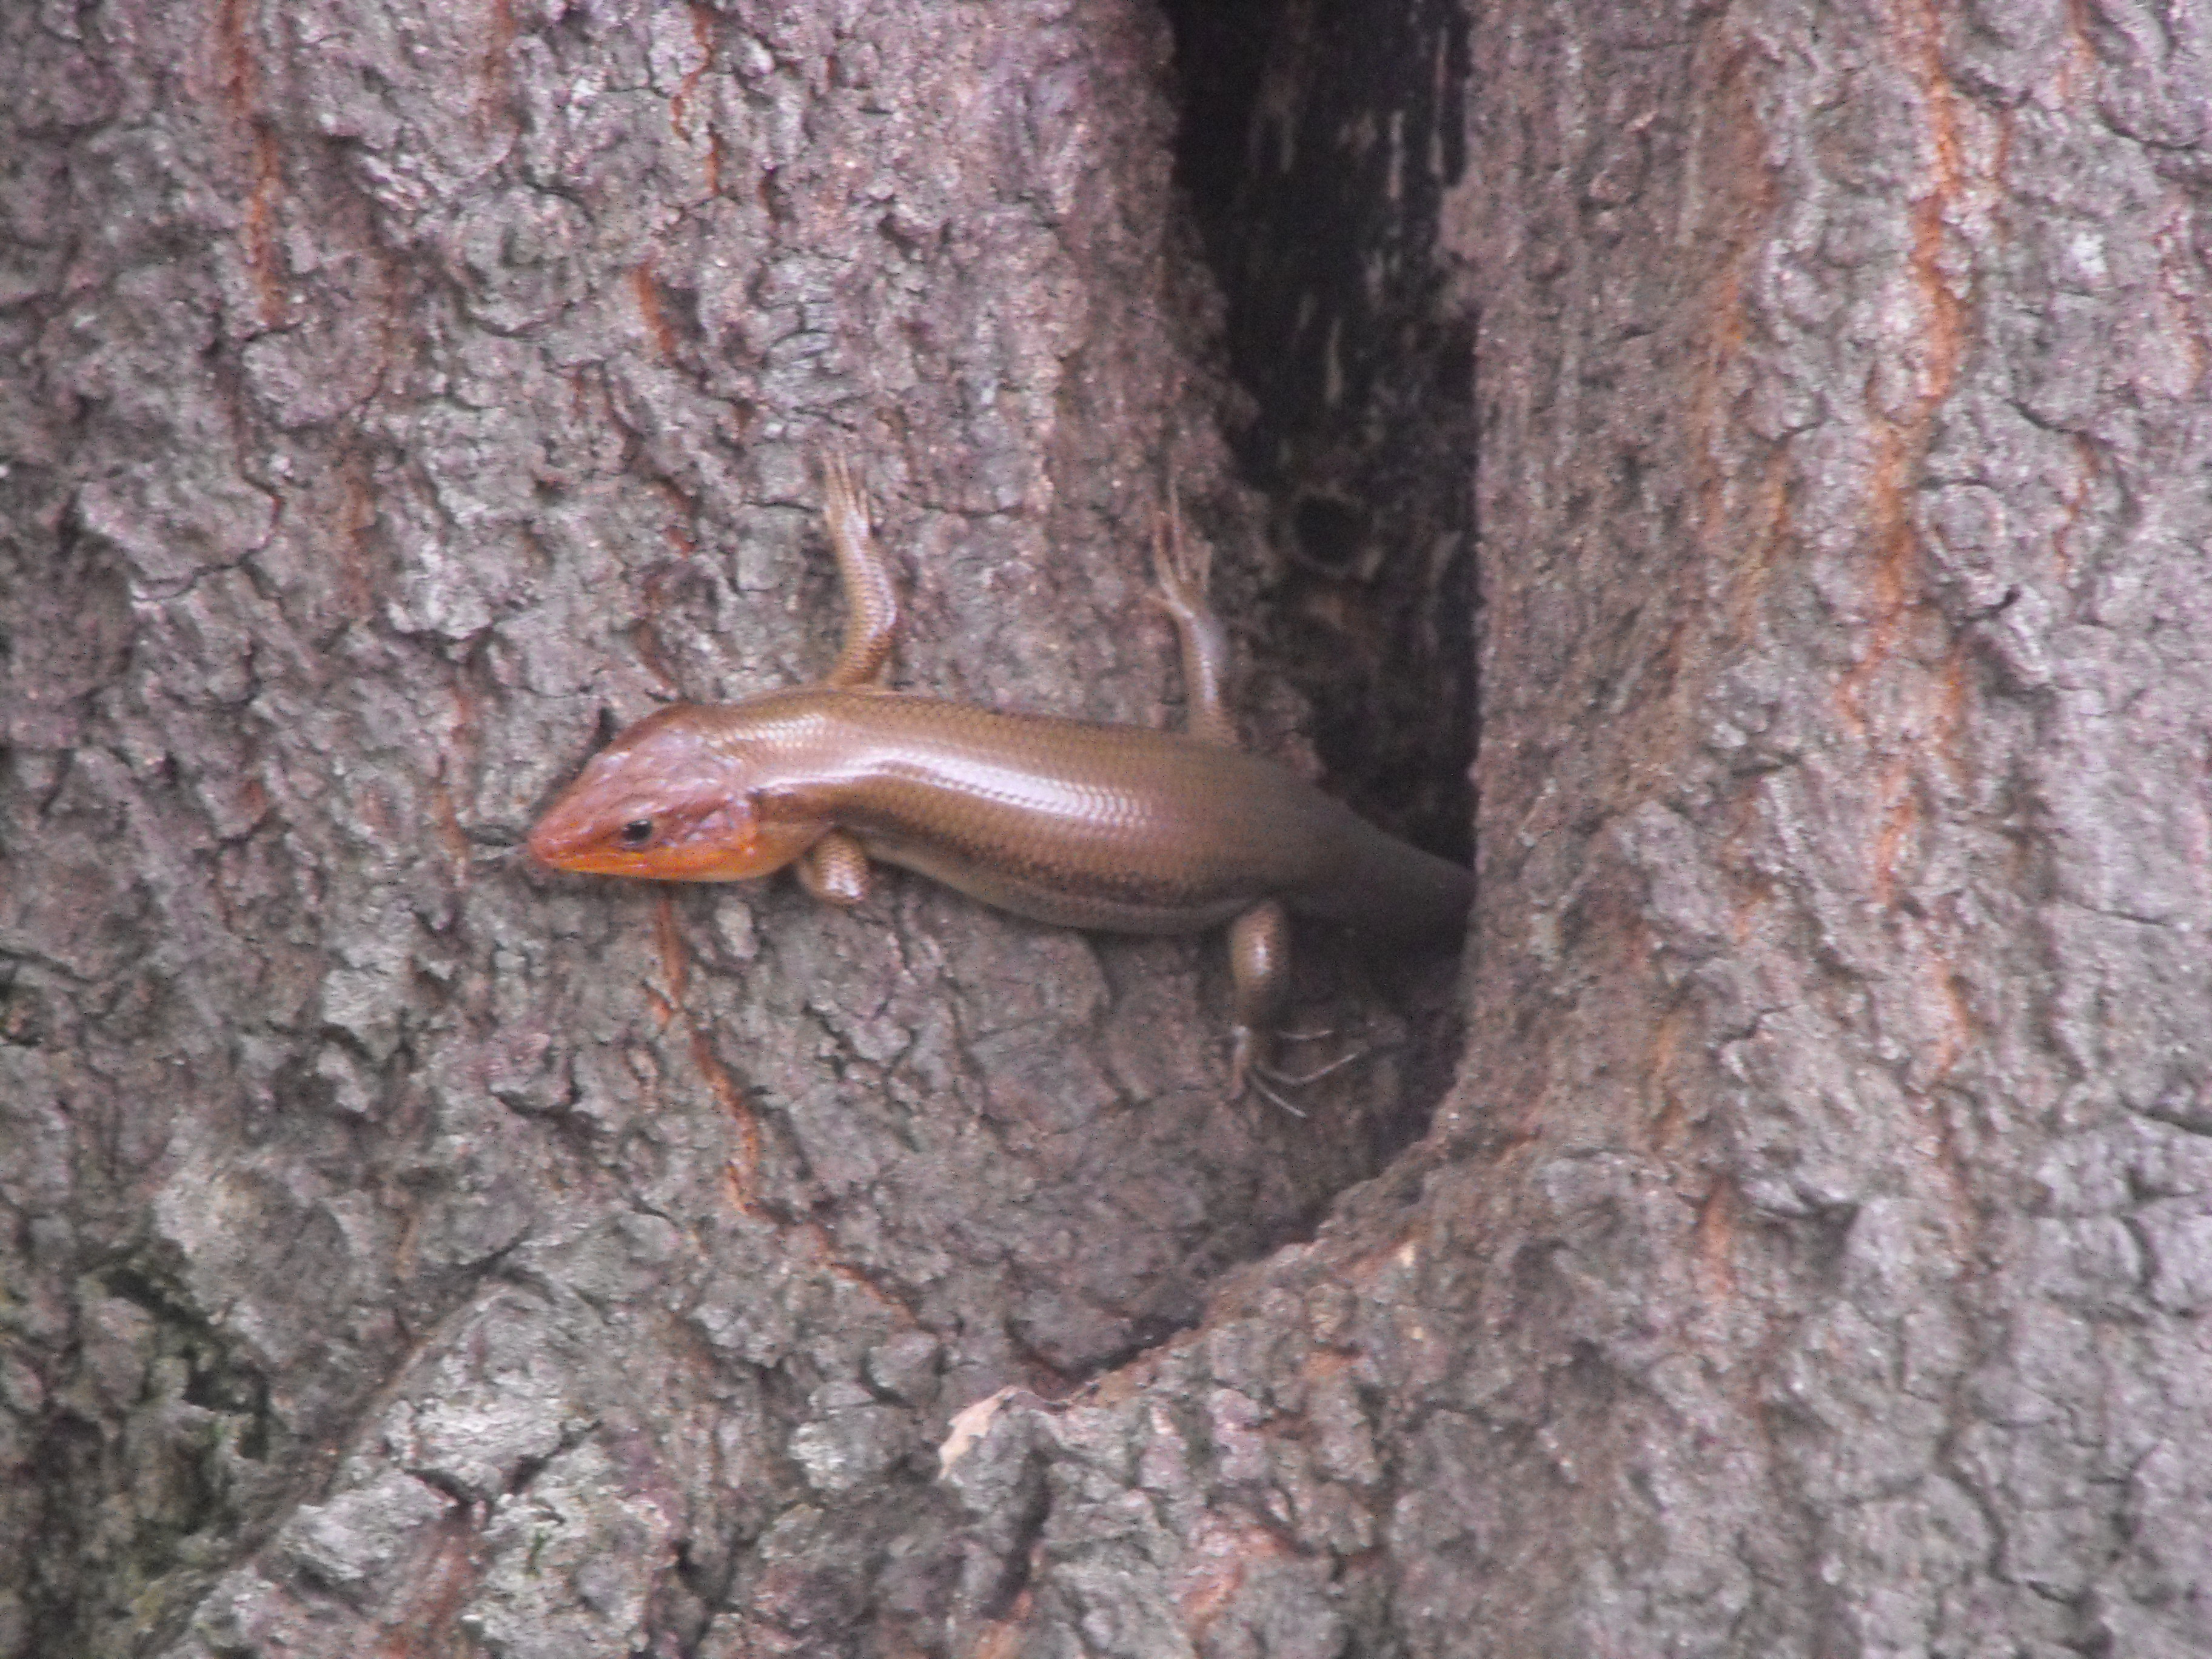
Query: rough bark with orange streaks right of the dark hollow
956 0 2212 1655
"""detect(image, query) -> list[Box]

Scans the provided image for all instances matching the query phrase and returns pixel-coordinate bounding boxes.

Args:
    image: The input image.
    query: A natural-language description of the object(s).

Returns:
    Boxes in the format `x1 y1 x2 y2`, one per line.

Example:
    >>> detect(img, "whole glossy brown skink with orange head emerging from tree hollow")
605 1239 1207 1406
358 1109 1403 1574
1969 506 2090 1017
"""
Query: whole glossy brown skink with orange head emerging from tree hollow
529 458 1473 1093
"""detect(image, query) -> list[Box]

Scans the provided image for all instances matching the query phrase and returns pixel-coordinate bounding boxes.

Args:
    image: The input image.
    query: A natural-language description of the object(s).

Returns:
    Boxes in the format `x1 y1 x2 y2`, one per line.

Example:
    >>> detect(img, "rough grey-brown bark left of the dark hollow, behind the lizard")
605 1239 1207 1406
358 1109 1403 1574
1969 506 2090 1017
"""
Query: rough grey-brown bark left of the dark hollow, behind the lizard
0 0 1451 1655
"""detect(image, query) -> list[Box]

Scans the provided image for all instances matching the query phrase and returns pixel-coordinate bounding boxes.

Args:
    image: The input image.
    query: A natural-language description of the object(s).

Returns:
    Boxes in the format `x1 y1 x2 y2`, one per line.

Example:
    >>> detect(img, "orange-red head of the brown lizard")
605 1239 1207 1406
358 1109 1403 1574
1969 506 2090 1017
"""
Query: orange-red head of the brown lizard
529 703 820 880
